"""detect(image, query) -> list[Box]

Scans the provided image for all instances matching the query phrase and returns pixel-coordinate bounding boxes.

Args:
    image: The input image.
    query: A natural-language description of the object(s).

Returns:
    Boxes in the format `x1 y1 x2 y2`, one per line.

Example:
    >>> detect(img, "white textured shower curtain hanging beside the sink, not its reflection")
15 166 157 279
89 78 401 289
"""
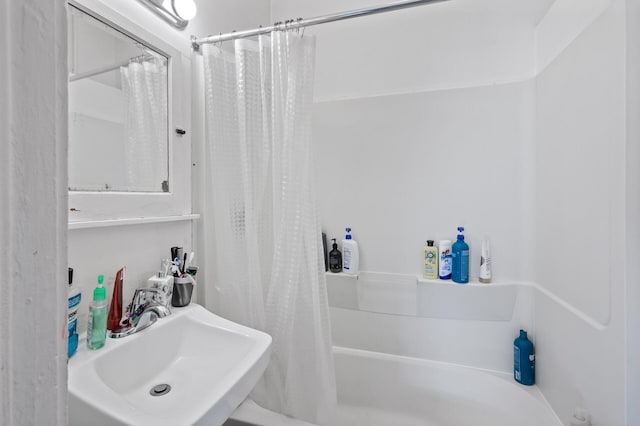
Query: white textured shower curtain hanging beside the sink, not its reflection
203 32 336 424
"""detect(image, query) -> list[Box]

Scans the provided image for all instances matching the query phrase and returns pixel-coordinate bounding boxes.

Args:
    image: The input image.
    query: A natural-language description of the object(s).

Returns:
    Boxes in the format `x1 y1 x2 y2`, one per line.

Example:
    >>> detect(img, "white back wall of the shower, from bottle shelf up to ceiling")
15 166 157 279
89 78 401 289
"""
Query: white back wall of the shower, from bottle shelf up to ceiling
272 0 551 280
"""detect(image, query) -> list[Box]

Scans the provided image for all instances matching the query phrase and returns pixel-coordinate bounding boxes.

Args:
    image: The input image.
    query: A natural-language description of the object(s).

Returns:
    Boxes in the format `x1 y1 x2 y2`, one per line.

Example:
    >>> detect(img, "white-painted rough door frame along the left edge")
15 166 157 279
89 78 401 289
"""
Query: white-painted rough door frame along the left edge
0 0 67 425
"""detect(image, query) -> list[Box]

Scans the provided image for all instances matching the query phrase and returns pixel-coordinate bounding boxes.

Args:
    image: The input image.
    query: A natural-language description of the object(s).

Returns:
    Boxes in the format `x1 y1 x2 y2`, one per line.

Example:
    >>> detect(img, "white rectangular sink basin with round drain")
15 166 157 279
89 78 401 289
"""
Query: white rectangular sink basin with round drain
69 304 271 426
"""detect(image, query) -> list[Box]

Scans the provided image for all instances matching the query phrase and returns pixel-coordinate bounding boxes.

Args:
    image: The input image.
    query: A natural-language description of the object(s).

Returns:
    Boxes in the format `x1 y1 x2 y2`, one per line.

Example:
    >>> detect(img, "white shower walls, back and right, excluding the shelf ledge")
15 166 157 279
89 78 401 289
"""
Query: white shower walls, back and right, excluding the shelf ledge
272 0 626 426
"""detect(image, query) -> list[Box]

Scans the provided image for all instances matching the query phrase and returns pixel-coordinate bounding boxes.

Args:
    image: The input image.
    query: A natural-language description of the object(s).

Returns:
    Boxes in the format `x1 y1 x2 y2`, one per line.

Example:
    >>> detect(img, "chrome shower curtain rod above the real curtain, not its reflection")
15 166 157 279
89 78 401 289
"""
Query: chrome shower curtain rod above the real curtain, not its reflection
191 0 448 50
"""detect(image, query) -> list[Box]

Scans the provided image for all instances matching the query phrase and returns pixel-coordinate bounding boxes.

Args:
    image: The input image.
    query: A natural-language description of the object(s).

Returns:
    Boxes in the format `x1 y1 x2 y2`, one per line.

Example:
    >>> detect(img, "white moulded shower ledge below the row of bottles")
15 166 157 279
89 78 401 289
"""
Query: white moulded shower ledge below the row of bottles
327 271 529 321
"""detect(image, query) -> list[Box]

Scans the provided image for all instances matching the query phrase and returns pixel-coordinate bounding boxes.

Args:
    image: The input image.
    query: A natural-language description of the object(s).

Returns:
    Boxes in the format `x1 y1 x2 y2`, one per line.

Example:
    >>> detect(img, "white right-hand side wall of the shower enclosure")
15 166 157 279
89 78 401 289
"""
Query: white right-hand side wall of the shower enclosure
534 0 624 426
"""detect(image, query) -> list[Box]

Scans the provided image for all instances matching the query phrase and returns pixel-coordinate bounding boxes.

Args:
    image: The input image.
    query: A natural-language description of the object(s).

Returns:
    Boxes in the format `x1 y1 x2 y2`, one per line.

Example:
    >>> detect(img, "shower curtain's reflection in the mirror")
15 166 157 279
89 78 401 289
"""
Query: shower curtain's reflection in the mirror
120 55 169 191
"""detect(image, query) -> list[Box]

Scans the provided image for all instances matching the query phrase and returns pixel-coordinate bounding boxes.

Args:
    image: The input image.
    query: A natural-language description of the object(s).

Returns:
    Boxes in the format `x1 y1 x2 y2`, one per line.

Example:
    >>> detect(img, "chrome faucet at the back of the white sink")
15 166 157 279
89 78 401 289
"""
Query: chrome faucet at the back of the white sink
109 288 171 339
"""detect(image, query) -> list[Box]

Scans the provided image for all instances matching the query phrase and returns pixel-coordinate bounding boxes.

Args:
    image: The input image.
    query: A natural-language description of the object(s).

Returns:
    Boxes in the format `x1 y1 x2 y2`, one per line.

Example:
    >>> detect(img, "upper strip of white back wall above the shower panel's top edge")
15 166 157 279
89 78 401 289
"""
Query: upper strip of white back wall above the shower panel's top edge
272 0 553 101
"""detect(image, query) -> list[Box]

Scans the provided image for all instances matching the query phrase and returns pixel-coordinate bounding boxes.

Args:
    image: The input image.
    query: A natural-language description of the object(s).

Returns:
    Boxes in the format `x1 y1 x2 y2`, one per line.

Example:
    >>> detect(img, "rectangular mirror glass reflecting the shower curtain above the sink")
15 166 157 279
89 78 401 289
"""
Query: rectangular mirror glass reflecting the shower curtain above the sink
69 7 169 192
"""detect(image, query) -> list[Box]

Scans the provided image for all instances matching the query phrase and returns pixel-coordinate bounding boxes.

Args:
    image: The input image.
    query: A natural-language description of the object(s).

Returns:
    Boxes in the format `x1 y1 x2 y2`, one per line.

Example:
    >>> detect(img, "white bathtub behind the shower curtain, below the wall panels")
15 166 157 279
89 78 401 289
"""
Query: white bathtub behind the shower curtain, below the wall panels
225 346 562 426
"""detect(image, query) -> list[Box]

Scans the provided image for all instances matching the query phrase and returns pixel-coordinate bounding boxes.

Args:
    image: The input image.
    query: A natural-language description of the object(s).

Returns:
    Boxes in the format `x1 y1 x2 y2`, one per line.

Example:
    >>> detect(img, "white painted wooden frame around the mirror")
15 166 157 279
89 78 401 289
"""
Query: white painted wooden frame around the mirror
67 0 191 224
